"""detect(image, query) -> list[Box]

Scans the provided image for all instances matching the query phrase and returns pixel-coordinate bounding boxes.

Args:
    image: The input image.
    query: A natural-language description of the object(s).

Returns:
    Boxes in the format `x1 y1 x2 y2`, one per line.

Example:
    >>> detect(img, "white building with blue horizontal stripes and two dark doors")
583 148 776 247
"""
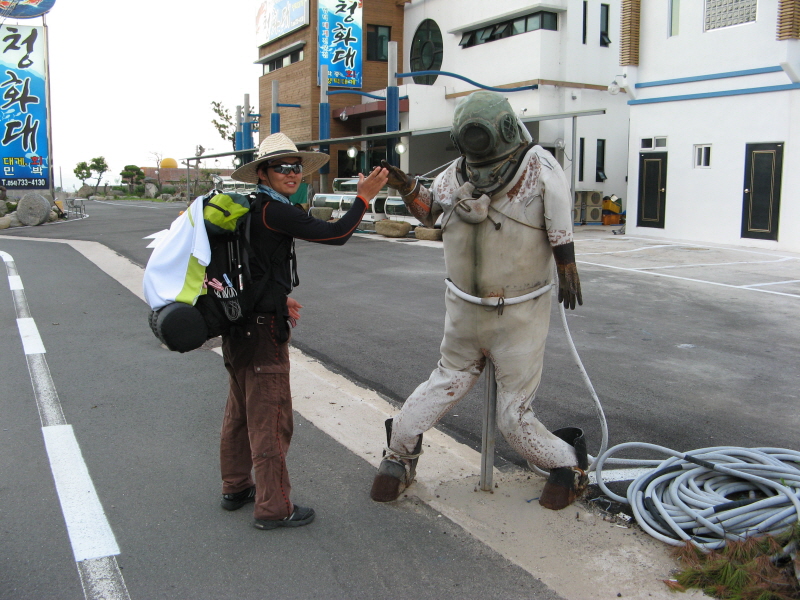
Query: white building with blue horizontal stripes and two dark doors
620 0 800 252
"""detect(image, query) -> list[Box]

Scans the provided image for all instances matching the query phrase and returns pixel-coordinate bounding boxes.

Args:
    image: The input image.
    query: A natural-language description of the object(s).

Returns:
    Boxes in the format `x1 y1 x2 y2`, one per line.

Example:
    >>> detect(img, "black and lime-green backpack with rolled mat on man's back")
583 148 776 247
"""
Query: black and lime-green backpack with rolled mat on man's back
145 190 294 352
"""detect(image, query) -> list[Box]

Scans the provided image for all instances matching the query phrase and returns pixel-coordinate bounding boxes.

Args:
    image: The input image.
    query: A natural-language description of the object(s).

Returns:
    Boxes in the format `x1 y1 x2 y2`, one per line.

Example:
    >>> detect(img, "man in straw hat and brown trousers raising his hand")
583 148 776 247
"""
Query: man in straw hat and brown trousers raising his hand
220 133 388 529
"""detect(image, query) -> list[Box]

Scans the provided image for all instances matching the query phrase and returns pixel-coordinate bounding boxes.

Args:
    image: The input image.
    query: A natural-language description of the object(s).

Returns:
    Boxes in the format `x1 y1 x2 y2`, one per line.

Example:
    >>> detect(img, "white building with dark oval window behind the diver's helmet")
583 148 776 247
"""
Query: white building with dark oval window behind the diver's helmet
334 0 628 216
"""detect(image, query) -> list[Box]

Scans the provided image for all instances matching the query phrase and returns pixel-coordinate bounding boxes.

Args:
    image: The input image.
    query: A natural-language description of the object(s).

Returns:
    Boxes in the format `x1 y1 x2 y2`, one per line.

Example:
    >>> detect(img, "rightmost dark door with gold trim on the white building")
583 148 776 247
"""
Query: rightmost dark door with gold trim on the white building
742 143 783 240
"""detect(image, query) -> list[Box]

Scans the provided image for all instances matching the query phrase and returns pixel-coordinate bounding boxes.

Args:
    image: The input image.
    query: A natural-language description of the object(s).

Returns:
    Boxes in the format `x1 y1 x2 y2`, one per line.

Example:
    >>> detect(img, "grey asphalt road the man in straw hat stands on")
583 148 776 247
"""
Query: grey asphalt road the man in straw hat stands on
0 203 559 600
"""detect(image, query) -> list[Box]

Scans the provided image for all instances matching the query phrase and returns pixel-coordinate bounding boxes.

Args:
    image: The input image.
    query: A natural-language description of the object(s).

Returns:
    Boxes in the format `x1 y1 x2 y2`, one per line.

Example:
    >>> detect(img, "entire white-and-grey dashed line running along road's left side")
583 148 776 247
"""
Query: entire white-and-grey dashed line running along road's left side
0 252 130 600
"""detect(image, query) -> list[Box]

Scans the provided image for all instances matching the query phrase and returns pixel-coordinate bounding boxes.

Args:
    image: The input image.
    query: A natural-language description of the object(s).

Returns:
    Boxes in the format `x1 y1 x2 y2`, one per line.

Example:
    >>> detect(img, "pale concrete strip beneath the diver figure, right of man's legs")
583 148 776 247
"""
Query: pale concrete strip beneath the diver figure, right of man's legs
291 349 702 600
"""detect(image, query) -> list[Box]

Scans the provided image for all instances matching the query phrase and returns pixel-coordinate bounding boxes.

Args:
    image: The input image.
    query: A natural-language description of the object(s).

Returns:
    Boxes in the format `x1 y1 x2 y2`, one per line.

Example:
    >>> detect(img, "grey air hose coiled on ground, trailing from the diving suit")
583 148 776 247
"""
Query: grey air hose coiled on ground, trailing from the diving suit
548 273 800 552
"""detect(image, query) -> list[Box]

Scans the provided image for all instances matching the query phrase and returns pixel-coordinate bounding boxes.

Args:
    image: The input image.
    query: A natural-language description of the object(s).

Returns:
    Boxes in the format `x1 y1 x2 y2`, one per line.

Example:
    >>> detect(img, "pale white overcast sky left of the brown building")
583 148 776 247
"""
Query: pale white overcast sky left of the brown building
5 0 261 191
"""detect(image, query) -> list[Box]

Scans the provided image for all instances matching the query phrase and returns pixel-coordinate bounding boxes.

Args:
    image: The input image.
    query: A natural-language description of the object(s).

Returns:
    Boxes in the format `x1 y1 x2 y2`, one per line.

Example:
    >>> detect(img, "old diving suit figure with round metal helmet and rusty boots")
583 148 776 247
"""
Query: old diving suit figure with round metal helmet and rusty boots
371 91 588 509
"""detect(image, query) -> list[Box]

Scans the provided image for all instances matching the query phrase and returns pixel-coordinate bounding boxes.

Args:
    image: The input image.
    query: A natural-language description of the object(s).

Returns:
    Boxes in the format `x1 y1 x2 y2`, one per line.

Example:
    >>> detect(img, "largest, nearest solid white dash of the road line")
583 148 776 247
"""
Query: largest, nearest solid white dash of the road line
42 425 119 562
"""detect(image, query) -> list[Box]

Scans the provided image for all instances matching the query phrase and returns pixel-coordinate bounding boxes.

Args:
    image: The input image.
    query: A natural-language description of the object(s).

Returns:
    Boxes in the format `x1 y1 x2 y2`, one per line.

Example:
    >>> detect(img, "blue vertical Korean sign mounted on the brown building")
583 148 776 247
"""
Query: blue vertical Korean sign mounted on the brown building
317 0 363 88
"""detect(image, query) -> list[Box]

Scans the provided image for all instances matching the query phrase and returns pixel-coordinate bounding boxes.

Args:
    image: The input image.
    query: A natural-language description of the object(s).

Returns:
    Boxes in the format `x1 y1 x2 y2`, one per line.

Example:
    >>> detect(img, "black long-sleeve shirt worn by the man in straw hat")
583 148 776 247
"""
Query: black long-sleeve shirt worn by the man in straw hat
250 194 367 302
